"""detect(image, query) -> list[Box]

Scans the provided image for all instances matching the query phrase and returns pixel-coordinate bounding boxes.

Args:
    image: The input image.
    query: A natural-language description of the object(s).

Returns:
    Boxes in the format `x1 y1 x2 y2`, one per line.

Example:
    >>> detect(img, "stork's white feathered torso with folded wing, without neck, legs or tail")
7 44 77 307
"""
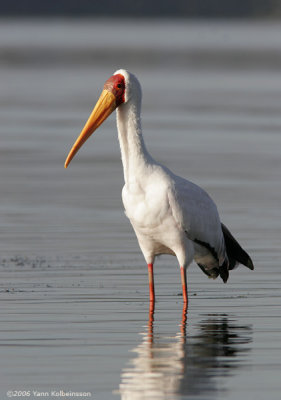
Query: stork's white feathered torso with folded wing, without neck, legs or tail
122 152 225 268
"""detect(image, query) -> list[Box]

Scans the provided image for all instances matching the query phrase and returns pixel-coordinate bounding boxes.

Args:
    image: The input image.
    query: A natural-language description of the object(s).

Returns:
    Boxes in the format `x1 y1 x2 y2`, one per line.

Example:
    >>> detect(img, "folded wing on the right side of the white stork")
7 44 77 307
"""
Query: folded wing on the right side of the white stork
168 176 226 265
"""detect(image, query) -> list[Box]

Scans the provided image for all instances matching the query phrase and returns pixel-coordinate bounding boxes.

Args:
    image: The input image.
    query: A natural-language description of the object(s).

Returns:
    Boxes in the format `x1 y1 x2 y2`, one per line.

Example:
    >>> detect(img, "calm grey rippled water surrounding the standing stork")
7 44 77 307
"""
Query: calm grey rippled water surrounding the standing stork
0 20 281 400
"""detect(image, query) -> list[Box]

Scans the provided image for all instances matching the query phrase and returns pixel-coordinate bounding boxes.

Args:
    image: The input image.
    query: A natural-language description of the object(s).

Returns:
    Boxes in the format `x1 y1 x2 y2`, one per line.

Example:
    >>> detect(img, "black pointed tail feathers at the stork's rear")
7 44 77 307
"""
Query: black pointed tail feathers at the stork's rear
220 224 254 272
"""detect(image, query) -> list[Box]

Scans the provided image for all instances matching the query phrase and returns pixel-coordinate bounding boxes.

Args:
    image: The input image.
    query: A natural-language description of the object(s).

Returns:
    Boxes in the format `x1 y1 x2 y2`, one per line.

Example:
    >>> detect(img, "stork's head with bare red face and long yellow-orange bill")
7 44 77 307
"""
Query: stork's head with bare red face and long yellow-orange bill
64 69 141 168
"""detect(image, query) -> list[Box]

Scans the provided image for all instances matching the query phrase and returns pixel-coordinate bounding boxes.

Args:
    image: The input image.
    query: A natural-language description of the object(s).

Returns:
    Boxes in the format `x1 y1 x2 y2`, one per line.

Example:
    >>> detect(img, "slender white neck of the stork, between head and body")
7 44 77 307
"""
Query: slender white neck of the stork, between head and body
117 101 155 184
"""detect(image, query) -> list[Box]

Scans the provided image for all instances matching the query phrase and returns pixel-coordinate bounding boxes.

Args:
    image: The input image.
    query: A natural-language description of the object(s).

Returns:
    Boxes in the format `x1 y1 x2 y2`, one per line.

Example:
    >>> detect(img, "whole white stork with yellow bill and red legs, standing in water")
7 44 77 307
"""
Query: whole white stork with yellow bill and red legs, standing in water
66 70 253 301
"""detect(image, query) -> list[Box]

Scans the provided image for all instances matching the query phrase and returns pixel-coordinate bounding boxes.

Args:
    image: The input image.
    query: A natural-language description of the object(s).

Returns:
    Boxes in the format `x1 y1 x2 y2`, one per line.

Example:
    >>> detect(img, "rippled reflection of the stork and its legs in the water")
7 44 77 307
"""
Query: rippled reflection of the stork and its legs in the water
119 307 252 400
